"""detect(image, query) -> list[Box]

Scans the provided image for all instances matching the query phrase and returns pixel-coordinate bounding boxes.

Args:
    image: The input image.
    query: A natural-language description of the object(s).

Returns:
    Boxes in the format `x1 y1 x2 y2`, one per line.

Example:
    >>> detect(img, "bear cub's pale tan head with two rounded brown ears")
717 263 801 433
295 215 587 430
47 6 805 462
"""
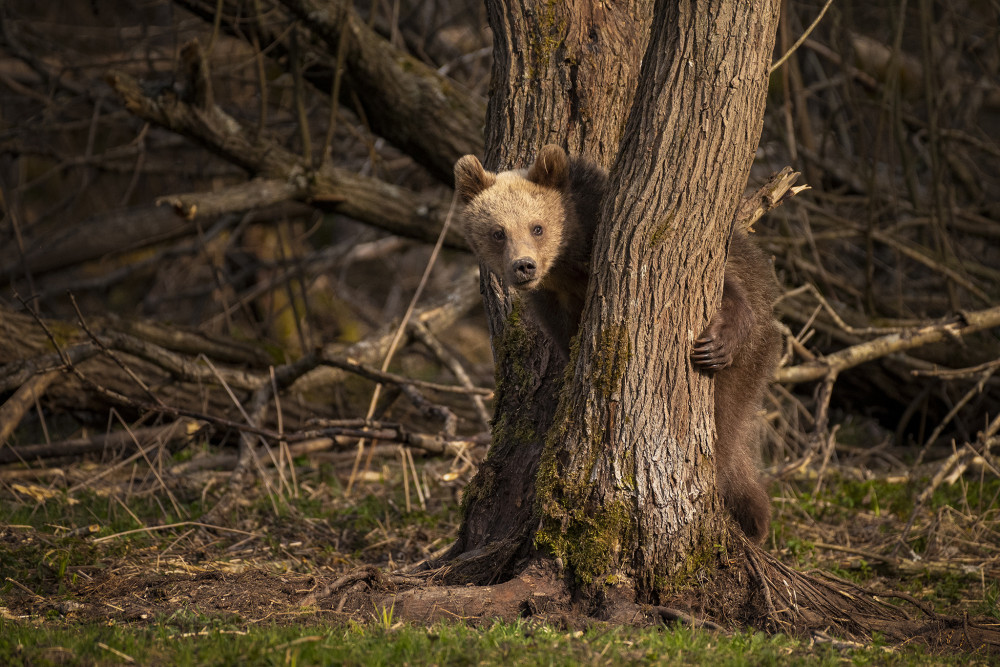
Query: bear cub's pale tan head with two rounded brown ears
455 144 575 291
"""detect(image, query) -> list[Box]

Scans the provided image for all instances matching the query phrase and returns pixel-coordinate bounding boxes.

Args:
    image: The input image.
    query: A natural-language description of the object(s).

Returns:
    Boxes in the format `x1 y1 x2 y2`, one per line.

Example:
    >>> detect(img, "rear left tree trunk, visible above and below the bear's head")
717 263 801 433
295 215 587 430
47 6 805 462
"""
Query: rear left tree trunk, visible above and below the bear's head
445 0 652 583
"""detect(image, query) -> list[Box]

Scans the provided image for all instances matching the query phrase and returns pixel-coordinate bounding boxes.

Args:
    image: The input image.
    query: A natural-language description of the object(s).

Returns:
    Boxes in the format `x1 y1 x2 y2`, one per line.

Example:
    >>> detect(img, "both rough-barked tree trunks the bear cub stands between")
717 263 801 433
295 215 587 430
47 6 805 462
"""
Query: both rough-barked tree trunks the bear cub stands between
449 0 778 597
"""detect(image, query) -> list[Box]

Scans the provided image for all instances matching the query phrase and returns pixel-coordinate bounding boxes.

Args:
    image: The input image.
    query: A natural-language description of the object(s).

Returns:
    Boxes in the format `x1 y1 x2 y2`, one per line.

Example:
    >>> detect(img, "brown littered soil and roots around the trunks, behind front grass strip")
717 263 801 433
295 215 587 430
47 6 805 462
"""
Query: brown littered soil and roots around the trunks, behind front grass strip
0 448 1000 651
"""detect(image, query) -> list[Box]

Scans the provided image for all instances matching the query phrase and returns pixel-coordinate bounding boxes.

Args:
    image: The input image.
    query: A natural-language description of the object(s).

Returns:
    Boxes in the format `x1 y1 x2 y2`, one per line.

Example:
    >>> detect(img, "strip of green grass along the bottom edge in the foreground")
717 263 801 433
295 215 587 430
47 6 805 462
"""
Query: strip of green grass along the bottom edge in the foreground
0 614 986 666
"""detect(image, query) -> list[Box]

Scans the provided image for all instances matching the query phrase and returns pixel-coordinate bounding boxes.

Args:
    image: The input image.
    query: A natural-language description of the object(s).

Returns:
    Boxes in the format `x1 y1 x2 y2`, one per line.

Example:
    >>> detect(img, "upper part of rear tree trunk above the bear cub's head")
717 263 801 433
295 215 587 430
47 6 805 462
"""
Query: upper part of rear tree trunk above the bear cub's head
485 0 653 170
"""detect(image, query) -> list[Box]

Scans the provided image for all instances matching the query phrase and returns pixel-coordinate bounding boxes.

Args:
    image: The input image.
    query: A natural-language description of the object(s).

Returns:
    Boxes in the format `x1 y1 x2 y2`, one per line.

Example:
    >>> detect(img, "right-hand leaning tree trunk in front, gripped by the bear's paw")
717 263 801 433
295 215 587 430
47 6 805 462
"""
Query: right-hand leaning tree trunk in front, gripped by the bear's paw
541 1 778 593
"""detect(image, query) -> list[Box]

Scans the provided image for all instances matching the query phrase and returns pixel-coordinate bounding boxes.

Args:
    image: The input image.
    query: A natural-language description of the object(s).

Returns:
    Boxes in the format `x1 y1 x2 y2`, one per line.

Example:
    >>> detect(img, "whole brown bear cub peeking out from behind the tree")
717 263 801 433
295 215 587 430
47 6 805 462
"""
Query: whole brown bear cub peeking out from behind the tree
455 145 780 541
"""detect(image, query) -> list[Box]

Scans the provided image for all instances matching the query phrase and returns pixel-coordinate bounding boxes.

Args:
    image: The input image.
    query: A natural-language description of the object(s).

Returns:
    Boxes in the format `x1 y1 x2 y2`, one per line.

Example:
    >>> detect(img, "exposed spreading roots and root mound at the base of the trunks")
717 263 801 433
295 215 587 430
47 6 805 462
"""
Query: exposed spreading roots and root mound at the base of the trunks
328 534 1000 653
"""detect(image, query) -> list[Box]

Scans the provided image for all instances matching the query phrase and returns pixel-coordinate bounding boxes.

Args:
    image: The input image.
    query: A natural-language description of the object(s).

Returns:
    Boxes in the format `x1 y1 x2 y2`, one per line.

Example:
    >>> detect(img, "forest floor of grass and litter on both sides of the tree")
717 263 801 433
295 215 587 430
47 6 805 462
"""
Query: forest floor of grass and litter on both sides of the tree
0 436 1000 664
